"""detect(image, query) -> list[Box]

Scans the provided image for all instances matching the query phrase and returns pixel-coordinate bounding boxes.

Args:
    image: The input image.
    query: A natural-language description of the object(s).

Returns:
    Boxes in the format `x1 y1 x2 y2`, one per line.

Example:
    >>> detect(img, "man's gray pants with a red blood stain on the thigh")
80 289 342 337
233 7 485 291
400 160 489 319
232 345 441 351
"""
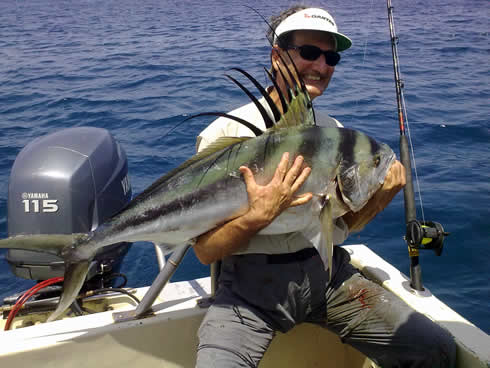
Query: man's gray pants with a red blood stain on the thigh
196 247 456 368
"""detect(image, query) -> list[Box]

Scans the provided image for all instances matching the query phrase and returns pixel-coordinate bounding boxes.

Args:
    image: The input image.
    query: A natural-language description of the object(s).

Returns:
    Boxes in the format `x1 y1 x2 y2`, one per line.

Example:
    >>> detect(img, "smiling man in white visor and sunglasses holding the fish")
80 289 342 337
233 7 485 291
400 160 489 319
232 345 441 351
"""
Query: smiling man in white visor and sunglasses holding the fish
194 7 455 367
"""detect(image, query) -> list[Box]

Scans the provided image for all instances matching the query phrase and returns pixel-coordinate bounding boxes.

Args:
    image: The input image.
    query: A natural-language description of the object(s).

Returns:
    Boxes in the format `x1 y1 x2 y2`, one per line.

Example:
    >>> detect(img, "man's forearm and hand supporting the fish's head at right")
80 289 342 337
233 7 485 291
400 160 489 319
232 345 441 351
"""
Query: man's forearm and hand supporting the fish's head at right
342 161 406 232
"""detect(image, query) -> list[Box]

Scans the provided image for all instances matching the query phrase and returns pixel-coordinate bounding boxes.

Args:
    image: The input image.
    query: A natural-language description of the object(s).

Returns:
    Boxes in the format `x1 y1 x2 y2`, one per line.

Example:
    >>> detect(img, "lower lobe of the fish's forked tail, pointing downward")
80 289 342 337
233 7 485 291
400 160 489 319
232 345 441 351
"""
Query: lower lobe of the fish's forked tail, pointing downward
47 261 90 322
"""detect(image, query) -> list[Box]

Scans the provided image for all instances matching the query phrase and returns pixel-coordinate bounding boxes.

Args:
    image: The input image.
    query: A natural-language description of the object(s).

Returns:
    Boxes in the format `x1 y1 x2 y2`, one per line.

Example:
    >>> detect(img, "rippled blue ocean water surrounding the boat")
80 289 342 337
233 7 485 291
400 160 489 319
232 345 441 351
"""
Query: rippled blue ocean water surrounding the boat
0 0 490 333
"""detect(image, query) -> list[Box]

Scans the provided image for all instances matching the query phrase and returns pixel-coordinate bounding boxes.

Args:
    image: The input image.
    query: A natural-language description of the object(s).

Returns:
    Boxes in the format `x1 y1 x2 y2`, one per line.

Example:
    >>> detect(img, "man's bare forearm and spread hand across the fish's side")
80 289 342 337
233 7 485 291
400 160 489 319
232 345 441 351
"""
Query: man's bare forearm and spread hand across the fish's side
194 152 312 264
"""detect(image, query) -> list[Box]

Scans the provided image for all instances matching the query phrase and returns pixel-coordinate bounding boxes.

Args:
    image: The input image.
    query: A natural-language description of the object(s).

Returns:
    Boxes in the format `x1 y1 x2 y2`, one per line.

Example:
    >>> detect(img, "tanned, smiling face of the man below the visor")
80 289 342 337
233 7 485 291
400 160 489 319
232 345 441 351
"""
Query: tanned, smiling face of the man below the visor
276 31 335 99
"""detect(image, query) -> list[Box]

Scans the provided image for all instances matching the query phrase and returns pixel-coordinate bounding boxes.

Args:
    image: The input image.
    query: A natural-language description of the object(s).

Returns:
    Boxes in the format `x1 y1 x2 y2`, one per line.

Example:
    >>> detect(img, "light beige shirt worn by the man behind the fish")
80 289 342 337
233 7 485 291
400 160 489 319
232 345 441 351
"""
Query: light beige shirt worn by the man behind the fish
196 98 349 254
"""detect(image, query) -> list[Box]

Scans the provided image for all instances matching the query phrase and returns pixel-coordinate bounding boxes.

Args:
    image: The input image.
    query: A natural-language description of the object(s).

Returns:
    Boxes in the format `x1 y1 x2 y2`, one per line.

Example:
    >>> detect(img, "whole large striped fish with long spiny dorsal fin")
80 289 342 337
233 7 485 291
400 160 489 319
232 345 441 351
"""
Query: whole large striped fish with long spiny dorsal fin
0 52 395 320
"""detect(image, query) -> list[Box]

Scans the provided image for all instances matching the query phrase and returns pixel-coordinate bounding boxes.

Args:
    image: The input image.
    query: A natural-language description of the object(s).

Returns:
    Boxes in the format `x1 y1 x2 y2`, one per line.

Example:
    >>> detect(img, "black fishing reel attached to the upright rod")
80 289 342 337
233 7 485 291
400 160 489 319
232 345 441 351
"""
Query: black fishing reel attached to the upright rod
405 220 449 256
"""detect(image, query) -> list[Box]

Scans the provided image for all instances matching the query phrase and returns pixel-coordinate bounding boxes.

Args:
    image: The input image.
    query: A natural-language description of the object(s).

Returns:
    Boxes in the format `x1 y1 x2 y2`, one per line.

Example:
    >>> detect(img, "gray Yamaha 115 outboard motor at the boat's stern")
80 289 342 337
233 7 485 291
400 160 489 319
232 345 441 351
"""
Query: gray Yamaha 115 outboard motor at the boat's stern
6 127 131 290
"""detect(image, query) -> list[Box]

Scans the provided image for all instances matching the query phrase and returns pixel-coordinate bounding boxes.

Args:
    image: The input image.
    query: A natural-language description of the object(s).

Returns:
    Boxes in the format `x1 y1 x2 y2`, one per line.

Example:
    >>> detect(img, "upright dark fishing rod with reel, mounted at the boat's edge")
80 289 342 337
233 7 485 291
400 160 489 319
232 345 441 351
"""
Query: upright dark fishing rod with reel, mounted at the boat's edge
387 0 449 291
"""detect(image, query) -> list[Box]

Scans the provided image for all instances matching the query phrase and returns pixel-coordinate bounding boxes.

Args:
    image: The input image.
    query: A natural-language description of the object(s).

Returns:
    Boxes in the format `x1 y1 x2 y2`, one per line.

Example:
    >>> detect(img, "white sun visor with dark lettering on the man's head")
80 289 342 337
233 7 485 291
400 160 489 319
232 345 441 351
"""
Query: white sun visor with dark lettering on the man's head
274 8 352 51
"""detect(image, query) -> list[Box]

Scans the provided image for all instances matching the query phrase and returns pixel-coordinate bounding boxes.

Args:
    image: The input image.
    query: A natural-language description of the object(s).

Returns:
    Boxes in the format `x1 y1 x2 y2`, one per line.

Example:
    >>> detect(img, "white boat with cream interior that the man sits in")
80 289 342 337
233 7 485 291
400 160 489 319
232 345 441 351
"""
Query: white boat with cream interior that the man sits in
0 245 490 368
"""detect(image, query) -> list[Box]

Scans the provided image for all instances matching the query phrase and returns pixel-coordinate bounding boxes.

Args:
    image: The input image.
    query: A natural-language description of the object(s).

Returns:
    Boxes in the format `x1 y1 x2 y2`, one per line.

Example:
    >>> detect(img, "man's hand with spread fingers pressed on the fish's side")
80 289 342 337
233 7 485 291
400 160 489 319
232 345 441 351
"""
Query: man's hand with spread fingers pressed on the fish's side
240 152 313 228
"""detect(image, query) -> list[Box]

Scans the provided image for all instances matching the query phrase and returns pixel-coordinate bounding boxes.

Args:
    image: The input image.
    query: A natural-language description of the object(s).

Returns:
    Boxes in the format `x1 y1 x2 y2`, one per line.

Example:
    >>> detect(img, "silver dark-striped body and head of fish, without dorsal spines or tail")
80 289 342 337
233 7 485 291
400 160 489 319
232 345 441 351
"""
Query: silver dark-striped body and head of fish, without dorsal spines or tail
73 126 394 252
